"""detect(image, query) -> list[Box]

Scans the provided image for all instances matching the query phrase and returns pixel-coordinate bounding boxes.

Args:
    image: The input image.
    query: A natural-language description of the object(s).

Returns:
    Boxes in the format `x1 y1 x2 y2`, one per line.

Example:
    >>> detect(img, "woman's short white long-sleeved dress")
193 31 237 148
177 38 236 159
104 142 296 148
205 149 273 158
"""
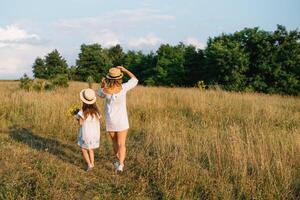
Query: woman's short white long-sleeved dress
98 78 138 132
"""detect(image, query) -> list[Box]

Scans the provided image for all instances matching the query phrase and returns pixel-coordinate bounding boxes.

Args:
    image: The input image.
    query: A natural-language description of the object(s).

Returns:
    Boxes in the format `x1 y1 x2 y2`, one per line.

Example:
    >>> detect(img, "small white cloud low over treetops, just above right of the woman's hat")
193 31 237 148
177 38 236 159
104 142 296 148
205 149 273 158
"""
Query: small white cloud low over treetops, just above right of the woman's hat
128 34 163 48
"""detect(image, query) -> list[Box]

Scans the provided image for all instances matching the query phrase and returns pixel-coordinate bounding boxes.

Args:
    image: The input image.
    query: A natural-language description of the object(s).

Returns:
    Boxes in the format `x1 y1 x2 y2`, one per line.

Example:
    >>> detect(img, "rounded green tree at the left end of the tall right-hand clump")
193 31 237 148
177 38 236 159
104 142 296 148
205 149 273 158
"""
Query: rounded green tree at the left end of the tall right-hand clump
205 35 249 90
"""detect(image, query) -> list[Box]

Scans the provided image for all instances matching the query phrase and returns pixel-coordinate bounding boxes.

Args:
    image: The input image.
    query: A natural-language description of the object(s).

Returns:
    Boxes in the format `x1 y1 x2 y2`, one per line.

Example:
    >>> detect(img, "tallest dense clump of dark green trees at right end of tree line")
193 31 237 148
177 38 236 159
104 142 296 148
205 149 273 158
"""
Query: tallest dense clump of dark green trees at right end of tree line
205 25 300 95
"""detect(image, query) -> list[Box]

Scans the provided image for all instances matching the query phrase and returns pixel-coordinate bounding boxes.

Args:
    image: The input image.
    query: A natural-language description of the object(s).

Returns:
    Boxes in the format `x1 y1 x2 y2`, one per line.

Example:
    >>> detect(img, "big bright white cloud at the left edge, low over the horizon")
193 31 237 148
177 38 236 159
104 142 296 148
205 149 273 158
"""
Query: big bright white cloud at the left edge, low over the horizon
0 25 50 79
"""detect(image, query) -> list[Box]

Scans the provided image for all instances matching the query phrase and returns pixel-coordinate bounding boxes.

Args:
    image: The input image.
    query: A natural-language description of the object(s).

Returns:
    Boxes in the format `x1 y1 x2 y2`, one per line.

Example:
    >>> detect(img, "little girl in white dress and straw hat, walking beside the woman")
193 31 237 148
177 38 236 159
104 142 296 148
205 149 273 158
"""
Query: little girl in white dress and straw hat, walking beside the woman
76 89 100 171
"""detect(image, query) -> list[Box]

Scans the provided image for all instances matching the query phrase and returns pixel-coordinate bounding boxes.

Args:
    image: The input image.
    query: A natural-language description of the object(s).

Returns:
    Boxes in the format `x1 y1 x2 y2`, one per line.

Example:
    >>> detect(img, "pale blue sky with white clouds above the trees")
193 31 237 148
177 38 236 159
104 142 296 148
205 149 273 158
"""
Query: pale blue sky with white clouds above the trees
0 0 300 79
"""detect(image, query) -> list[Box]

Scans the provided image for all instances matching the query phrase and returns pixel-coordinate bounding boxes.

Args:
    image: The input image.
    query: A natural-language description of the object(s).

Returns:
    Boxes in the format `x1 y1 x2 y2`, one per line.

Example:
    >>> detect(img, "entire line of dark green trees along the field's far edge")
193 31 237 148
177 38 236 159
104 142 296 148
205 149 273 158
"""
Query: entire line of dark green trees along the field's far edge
33 25 300 95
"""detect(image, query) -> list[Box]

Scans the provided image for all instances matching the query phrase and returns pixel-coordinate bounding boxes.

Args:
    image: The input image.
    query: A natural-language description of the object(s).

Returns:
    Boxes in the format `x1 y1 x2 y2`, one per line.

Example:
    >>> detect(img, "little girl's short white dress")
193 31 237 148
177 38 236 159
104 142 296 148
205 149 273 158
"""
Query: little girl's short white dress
76 110 100 149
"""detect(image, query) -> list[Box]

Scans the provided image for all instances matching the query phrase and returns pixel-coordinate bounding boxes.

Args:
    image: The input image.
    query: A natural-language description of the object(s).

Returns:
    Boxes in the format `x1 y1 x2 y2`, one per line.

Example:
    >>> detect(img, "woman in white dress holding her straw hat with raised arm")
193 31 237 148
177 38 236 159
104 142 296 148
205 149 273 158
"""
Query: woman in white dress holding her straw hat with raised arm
98 66 138 172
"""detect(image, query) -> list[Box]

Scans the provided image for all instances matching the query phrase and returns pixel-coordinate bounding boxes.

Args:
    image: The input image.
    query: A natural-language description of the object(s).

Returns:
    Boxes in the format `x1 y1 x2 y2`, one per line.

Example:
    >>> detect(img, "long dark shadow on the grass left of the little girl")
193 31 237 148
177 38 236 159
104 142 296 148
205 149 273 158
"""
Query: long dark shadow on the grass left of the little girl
9 126 82 166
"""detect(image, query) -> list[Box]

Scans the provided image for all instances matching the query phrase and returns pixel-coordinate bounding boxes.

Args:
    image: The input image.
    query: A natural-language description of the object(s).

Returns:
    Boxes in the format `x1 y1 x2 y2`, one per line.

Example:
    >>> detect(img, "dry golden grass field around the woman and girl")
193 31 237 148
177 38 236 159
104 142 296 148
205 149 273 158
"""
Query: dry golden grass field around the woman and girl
0 82 300 199
